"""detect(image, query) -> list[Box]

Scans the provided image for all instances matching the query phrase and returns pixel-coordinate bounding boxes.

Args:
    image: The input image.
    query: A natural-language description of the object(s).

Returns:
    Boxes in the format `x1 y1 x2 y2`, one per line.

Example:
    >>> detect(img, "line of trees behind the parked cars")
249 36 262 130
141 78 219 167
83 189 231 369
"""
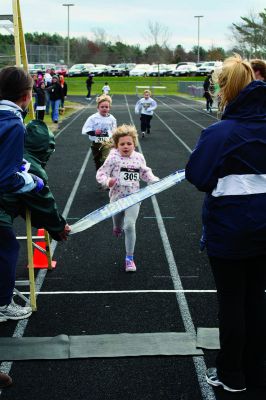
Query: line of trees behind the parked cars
0 9 266 64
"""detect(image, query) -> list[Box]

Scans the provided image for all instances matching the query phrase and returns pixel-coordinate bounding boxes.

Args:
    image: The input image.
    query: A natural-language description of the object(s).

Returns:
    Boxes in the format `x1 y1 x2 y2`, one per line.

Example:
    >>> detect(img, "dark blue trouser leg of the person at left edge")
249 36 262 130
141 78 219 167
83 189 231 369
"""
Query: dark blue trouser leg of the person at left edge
0 226 19 306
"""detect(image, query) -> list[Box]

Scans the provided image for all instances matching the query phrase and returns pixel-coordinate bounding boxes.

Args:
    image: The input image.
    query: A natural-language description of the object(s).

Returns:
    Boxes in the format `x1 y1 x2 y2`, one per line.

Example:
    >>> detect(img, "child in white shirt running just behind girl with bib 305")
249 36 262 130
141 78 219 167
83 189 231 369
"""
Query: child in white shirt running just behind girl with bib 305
82 95 116 171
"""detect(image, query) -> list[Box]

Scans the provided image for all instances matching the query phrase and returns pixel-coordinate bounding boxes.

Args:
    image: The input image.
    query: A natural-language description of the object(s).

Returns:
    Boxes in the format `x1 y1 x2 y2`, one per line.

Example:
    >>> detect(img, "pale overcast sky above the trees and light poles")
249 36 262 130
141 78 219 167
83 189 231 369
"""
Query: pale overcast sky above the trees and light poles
0 0 266 50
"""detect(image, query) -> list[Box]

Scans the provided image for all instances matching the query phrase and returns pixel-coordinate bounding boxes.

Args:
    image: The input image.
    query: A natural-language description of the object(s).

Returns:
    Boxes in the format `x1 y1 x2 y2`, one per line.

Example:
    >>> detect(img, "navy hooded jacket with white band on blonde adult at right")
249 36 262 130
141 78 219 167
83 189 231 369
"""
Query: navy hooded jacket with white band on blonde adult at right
186 81 266 259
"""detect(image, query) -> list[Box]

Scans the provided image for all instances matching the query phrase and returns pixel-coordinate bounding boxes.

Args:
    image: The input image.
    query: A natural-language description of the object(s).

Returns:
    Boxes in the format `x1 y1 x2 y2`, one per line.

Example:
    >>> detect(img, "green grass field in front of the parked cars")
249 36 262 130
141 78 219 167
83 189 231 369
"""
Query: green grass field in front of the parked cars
66 76 204 96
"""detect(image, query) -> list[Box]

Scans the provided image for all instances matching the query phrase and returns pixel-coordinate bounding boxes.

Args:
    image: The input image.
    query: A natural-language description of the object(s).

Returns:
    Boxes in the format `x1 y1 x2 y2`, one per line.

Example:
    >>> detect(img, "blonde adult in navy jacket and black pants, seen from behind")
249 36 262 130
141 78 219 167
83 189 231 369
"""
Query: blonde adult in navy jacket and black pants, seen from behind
186 55 266 392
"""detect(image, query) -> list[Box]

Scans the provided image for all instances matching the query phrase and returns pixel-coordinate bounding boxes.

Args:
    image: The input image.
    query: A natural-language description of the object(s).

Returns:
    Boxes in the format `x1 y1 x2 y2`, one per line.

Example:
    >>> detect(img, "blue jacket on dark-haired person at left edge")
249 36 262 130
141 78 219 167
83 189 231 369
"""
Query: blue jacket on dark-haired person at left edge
0 100 34 194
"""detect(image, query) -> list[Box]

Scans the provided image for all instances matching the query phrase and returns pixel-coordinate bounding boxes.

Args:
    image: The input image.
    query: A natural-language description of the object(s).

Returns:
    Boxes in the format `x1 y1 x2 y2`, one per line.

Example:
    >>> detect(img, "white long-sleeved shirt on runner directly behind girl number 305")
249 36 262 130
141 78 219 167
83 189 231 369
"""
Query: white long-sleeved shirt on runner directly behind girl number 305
82 112 117 143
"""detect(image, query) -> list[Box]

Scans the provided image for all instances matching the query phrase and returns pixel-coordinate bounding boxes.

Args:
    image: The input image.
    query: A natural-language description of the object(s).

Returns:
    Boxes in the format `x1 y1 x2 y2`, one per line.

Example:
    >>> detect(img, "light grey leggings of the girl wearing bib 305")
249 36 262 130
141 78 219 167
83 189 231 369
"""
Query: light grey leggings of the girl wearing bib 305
113 203 140 255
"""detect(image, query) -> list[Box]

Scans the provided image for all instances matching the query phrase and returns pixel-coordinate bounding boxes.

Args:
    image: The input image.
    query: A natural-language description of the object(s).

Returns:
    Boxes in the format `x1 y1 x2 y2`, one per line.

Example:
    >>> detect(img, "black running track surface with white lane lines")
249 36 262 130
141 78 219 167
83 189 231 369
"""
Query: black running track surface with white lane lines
0 95 265 400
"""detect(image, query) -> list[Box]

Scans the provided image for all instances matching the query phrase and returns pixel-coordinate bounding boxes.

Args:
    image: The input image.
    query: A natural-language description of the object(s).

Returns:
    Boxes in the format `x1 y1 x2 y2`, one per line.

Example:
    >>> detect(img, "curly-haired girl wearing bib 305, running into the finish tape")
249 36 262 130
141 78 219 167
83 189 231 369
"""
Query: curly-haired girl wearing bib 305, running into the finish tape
96 124 159 272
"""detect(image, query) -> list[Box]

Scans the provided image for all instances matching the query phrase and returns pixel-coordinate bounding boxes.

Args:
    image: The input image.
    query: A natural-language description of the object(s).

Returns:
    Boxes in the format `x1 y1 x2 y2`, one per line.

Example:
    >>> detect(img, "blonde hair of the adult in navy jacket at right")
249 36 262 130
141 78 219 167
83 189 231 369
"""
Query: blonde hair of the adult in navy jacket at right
217 54 255 110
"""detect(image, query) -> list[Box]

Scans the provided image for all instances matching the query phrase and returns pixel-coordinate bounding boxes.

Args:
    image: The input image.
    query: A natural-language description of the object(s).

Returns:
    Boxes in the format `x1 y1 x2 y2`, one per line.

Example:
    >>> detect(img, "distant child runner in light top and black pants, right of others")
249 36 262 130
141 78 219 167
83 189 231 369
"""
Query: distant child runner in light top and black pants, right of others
135 90 157 137
